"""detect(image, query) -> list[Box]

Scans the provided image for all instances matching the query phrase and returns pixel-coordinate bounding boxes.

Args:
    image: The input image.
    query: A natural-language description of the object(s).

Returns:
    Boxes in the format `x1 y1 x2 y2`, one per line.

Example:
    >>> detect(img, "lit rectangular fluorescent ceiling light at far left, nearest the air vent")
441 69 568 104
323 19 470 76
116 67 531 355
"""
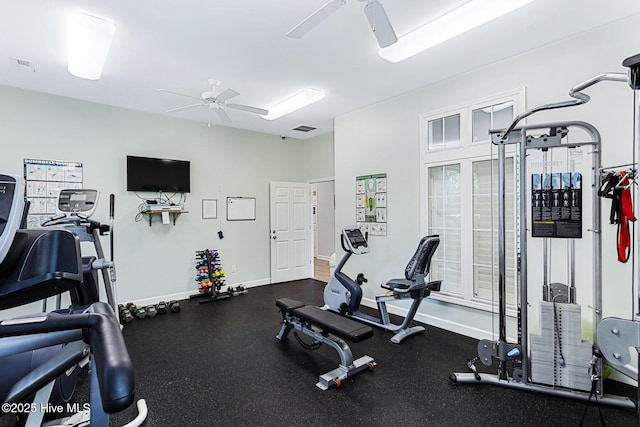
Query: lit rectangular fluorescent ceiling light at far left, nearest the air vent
67 12 116 80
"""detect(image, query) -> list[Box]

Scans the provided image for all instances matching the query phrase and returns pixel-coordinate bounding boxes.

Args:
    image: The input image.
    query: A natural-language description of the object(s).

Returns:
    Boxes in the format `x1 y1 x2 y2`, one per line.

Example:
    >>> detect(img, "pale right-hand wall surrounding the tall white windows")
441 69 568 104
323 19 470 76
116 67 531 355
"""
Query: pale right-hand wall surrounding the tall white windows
335 15 640 338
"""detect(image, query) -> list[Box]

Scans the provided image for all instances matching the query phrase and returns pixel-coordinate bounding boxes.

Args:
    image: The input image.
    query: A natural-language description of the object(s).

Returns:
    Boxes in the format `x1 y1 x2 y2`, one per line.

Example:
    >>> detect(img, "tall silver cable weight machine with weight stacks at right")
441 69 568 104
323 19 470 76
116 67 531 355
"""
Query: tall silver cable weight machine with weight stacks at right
450 55 640 409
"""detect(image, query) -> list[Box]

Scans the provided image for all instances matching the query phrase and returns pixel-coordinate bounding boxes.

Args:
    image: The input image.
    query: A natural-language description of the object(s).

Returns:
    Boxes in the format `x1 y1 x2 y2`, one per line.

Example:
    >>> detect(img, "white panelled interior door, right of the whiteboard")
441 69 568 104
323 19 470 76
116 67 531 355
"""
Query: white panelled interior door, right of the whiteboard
269 181 313 283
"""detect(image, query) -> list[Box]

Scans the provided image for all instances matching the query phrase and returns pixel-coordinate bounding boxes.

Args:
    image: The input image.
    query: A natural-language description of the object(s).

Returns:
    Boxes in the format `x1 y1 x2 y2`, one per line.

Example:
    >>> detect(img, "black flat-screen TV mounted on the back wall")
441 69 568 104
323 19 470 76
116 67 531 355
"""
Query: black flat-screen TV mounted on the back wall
127 156 191 193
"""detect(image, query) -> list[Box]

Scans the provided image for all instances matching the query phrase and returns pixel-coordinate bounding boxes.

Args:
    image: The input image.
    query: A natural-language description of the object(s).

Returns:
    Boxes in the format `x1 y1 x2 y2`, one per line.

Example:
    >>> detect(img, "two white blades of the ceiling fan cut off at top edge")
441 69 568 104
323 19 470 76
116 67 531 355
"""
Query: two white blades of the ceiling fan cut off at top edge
287 0 398 47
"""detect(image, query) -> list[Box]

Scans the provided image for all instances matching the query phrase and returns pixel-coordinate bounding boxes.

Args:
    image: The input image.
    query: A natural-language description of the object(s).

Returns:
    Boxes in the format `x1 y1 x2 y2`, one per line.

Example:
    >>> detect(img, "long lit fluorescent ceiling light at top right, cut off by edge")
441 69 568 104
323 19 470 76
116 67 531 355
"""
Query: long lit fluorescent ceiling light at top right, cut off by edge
378 0 534 63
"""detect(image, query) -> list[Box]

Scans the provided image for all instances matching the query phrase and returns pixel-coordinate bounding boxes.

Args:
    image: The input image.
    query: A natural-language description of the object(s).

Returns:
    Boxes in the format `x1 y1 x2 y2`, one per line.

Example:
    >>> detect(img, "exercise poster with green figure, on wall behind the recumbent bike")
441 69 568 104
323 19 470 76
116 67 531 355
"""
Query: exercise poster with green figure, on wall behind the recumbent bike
356 173 387 236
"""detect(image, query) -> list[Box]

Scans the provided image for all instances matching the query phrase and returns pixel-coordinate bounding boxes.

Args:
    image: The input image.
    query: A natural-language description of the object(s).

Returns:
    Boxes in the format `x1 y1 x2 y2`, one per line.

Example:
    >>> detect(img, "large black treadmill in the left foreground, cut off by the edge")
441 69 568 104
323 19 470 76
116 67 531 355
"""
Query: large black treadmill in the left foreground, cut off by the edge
0 175 144 426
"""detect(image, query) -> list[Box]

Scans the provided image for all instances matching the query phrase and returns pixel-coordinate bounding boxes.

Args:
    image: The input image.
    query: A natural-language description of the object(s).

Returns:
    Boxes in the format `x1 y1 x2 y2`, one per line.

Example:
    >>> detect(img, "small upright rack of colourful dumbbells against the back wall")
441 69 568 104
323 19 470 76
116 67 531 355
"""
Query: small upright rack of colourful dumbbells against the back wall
190 249 247 304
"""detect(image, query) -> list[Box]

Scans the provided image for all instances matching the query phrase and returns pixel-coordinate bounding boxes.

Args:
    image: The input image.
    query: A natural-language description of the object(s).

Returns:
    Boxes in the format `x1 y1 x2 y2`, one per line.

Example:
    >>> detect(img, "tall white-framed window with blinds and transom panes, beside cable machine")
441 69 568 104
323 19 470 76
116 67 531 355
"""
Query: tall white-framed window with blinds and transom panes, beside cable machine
421 90 524 309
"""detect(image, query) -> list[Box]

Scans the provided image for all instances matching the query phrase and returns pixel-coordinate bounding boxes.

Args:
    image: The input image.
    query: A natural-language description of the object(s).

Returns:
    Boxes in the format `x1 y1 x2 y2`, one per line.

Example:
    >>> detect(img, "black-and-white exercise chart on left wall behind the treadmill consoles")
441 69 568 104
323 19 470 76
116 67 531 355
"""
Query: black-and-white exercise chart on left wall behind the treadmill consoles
24 159 82 228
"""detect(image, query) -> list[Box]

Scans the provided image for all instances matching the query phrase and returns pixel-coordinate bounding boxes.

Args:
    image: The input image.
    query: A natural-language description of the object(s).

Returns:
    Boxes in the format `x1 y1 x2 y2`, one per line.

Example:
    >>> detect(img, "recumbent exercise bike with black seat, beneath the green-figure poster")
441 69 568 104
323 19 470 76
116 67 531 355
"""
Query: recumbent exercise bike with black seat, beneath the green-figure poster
323 227 442 344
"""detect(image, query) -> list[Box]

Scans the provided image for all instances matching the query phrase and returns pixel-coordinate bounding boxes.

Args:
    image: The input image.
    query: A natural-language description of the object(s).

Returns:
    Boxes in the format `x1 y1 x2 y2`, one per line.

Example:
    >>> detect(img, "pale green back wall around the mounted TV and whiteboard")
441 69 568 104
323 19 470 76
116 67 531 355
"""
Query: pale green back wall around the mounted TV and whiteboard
0 86 316 314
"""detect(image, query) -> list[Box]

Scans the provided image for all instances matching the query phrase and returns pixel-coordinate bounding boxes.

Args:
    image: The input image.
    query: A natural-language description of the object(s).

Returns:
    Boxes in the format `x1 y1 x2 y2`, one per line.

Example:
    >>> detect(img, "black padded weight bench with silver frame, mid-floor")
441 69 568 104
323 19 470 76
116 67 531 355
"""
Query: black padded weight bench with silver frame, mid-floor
276 298 376 390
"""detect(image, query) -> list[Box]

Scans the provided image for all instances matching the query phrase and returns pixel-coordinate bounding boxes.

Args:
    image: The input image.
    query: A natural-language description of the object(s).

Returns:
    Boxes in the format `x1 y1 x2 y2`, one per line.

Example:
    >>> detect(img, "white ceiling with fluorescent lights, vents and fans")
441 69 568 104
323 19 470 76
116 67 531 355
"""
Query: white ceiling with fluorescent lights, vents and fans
0 0 640 139
